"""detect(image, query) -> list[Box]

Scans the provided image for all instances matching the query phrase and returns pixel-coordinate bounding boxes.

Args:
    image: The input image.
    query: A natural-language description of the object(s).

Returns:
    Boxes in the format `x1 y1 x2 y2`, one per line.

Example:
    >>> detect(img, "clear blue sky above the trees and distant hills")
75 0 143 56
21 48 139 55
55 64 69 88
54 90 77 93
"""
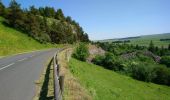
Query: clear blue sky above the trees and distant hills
2 0 170 40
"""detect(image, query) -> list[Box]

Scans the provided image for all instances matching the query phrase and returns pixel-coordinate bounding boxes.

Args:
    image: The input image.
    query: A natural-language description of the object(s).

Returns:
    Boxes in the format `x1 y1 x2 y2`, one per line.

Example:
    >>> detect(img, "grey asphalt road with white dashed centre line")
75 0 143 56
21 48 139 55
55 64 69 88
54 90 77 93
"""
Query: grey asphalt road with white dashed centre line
0 49 58 100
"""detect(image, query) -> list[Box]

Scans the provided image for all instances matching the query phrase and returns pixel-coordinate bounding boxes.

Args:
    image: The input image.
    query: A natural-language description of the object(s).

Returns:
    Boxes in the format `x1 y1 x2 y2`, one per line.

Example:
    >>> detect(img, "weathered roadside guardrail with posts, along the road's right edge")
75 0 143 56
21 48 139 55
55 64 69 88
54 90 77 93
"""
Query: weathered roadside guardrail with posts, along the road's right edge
53 50 64 100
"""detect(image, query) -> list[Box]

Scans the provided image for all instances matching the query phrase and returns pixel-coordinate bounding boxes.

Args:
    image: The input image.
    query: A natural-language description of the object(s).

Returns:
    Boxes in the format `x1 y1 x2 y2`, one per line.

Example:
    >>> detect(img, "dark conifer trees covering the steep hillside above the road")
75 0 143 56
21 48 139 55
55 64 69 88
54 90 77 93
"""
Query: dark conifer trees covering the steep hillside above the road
0 0 89 44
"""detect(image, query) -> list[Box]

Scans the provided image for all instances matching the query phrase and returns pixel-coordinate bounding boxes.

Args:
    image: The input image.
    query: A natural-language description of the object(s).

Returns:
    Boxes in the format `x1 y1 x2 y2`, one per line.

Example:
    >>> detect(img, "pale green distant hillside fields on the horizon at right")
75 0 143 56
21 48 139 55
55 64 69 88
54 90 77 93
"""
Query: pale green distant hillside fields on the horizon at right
98 33 170 47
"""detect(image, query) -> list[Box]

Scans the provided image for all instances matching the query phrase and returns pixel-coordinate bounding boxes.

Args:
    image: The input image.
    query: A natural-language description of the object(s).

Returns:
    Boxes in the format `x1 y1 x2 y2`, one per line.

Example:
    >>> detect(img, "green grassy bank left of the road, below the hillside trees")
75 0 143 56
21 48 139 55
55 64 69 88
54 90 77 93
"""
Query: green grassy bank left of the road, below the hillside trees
0 17 53 56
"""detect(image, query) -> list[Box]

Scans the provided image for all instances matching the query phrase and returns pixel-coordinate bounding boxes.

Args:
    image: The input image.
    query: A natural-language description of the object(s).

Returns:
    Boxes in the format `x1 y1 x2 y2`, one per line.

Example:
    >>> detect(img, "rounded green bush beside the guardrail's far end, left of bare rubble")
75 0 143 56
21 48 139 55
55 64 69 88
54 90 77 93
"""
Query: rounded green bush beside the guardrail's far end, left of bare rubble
73 43 89 61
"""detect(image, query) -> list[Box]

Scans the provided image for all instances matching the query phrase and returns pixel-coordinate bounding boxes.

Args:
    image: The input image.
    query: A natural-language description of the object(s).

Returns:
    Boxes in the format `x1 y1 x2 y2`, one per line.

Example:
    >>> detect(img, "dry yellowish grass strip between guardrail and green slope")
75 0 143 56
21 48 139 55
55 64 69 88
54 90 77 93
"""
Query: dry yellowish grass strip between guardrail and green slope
58 50 92 100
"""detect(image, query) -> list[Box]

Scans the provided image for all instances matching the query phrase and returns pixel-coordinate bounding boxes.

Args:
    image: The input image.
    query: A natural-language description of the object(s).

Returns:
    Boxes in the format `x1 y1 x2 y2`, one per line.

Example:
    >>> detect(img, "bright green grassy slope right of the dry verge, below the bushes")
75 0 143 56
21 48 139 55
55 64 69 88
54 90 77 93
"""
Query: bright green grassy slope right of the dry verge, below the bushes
69 59 170 100
